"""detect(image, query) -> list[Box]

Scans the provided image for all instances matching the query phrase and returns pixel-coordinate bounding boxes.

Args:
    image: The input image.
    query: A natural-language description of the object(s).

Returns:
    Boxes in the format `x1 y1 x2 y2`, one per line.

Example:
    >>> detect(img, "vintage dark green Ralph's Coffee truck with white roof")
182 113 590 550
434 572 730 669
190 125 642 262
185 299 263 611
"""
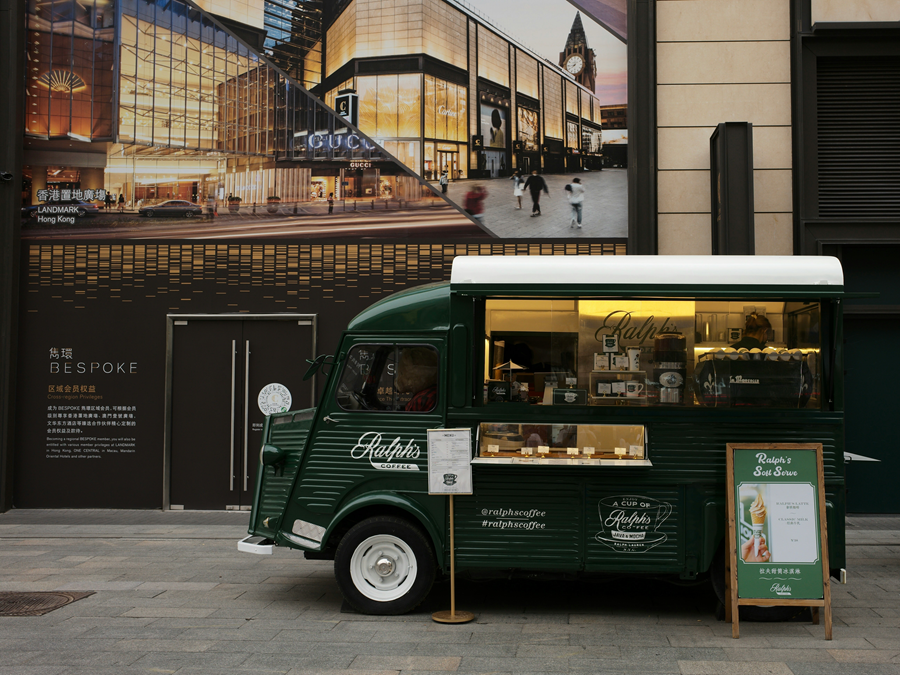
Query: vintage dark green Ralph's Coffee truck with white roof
238 256 845 614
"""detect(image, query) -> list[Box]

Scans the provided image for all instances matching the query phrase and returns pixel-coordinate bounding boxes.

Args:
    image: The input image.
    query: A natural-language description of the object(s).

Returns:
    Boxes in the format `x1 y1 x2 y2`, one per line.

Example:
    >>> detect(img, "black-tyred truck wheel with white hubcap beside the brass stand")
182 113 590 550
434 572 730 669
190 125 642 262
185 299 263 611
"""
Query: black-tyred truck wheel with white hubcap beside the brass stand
334 516 435 614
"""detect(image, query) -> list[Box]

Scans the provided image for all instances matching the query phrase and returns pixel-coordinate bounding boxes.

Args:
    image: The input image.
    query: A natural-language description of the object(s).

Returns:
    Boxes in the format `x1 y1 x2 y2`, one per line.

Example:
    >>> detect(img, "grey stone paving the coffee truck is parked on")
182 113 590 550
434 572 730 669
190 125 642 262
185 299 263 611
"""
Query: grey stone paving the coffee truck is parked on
0 511 900 675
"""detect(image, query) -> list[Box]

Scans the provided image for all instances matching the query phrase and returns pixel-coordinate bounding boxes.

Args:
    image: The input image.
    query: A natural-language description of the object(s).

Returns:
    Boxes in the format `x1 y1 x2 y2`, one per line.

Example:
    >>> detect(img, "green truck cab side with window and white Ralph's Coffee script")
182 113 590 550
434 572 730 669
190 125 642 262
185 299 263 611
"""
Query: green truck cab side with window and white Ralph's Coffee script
283 337 446 532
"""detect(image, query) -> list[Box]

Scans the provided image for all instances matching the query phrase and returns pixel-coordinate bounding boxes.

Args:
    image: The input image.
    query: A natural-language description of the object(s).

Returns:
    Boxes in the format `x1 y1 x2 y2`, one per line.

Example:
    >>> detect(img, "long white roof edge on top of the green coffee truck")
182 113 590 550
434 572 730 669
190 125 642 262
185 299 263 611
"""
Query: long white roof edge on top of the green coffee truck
450 255 844 286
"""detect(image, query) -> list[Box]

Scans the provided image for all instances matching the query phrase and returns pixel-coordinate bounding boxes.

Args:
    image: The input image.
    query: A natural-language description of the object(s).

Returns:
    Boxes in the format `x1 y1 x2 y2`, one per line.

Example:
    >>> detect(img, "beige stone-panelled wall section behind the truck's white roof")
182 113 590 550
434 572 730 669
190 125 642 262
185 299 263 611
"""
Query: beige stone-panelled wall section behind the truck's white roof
656 0 793 255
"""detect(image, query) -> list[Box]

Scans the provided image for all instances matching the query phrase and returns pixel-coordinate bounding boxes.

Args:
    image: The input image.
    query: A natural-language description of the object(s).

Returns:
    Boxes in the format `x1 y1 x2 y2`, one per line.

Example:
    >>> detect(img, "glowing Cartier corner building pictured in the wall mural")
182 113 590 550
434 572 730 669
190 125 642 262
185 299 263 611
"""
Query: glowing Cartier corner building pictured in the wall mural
316 0 602 180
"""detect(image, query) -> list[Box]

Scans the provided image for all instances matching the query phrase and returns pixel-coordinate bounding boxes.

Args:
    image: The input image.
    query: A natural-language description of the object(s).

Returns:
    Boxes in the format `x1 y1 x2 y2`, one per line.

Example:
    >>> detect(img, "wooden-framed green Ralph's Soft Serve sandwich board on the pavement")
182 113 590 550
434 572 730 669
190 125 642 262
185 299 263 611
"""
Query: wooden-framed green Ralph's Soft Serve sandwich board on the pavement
726 443 831 640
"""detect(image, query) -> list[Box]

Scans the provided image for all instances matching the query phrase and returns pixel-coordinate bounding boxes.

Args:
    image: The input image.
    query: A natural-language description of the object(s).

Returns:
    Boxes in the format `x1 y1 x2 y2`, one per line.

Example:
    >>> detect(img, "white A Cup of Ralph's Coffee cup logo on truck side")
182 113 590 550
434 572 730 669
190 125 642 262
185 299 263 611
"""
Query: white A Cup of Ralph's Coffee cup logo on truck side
594 495 672 553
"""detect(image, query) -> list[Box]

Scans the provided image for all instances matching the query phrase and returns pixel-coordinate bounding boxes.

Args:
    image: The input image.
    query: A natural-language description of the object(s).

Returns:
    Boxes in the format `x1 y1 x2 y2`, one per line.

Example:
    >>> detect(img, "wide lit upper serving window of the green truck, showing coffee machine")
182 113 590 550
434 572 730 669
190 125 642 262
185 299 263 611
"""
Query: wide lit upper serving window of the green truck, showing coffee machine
484 298 822 408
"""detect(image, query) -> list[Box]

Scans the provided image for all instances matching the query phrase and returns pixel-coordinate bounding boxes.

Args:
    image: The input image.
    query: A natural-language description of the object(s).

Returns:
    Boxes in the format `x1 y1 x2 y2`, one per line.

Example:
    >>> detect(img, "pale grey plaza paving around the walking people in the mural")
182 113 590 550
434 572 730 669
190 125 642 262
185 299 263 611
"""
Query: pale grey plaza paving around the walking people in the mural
436 169 628 239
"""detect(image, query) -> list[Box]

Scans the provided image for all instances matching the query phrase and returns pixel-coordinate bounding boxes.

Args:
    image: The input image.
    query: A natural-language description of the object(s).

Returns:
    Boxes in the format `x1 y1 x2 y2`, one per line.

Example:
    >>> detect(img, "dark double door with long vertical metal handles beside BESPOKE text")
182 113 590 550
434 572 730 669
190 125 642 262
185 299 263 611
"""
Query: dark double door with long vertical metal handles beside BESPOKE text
169 315 315 510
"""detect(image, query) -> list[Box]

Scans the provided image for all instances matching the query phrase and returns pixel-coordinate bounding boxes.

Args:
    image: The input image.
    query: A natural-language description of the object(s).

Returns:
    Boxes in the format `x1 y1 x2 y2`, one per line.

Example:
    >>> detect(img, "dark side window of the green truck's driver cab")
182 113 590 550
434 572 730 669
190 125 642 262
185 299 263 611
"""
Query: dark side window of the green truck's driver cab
337 344 438 413
